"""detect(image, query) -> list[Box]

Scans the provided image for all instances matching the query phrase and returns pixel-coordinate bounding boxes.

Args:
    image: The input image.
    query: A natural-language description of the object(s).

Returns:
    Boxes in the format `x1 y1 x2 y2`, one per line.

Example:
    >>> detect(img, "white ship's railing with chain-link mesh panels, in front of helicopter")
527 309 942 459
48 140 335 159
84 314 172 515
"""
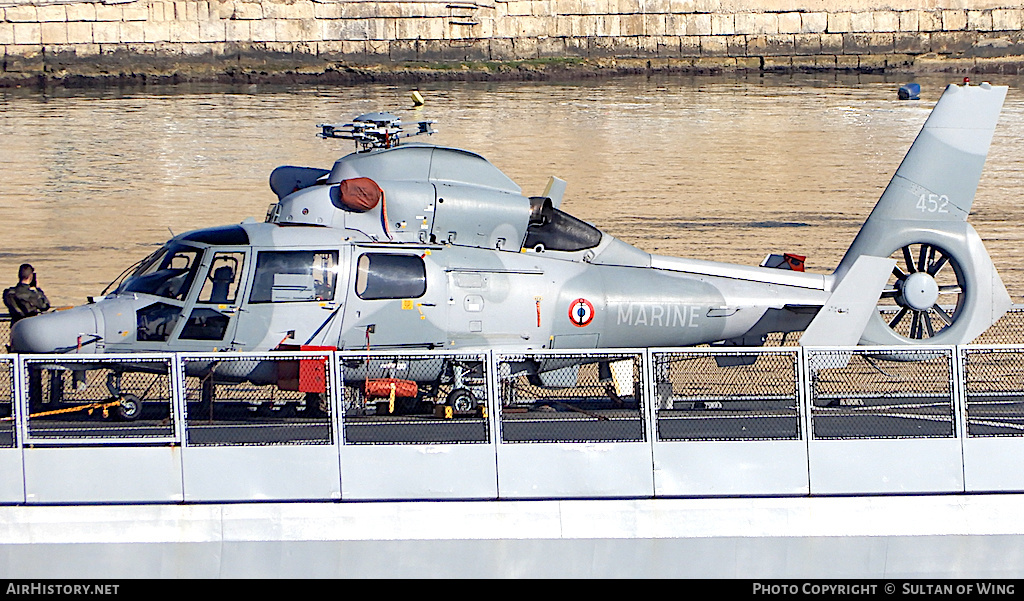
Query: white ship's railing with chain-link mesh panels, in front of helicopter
0 345 1024 505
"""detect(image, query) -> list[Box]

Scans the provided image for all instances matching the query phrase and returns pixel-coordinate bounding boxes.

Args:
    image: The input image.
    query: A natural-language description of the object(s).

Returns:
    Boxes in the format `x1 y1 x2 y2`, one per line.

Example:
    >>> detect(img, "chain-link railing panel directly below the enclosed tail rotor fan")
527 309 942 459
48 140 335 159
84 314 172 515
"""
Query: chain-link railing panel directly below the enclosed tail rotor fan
807 348 956 439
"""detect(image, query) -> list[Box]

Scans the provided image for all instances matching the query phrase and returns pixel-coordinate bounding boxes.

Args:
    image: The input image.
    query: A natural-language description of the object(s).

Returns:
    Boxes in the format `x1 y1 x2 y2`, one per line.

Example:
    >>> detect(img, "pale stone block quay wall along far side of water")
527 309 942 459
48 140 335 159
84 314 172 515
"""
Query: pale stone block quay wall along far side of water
0 0 1024 82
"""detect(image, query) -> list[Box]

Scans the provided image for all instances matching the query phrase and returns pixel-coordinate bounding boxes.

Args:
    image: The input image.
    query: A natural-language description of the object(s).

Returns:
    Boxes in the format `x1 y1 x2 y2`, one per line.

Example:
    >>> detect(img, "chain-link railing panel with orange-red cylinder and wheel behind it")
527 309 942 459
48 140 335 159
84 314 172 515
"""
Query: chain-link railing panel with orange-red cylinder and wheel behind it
339 352 490 444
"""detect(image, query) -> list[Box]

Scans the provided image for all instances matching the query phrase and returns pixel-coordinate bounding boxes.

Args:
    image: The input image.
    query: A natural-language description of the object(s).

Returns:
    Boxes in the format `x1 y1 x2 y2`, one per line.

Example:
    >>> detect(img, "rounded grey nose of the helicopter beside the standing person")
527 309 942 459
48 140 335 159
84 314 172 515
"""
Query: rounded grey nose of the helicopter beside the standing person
10 306 102 353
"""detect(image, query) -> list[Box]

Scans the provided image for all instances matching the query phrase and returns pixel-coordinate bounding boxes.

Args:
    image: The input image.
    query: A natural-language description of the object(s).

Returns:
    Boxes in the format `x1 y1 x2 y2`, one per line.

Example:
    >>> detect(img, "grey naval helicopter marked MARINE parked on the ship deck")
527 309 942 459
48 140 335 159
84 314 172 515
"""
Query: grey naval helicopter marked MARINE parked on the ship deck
11 83 1011 417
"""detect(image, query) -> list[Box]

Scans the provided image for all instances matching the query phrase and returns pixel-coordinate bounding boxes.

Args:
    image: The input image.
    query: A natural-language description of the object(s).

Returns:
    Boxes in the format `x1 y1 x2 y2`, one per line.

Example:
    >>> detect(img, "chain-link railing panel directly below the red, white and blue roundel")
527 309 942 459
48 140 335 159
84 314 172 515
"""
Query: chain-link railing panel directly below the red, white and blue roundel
497 353 646 442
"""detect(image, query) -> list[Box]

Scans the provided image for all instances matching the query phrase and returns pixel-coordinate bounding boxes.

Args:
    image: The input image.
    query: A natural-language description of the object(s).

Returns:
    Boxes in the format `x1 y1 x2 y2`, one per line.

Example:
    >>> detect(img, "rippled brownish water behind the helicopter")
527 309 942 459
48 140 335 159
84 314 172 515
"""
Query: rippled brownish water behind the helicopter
0 76 1024 306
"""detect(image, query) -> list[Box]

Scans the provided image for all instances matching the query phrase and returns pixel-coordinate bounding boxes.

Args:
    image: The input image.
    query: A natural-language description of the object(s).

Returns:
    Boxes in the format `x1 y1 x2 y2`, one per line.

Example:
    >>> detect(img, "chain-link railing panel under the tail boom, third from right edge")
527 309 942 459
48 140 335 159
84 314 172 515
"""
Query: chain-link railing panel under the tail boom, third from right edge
652 350 801 440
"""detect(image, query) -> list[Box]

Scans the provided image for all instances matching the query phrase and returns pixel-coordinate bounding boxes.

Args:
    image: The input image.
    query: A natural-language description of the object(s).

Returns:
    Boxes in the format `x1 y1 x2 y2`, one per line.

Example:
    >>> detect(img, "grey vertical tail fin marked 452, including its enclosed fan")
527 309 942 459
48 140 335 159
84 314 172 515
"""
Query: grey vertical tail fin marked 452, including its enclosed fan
835 83 1011 344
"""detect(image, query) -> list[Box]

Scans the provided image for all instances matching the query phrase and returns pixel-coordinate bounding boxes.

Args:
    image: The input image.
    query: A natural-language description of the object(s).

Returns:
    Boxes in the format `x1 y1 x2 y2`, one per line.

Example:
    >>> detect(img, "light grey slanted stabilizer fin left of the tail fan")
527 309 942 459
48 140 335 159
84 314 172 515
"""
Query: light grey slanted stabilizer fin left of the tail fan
800 255 896 346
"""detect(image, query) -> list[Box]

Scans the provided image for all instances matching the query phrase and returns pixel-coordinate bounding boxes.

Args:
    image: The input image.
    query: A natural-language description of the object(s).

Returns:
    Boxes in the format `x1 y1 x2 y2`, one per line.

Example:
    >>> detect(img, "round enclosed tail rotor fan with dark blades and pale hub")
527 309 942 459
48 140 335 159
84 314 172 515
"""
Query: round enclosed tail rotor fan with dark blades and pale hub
881 243 967 340
